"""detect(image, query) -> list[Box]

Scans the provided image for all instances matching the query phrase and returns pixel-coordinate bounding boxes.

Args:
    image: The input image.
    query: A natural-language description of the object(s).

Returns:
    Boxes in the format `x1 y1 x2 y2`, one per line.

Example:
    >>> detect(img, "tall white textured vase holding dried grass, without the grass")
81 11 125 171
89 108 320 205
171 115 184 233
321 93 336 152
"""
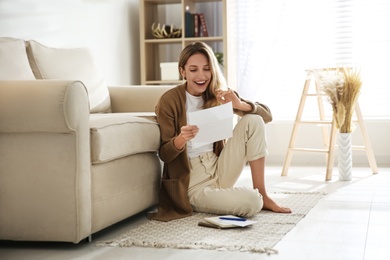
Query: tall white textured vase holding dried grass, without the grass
337 133 352 181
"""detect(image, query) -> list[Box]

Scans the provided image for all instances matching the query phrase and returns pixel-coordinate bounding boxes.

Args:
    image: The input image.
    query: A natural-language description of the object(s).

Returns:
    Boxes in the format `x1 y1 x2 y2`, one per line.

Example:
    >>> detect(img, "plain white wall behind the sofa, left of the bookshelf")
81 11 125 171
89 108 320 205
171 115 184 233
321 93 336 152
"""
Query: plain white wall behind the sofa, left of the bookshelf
0 0 140 85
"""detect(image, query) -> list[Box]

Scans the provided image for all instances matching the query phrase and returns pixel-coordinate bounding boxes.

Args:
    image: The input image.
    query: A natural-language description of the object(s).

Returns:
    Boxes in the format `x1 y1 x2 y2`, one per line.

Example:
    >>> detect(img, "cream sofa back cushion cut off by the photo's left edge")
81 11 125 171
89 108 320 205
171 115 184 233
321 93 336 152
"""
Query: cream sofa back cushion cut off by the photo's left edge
0 38 35 80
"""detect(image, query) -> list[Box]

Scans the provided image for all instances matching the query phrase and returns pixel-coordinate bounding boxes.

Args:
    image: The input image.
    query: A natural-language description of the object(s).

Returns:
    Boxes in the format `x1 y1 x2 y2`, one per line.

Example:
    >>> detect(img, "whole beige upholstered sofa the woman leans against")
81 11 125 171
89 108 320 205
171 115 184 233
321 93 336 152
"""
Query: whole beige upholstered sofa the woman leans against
0 38 171 243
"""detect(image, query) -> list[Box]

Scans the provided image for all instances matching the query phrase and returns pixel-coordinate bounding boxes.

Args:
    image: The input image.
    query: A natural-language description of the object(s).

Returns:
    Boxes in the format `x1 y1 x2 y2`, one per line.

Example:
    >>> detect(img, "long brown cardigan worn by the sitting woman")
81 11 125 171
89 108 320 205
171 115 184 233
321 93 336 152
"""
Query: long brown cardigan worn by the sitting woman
148 83 272 221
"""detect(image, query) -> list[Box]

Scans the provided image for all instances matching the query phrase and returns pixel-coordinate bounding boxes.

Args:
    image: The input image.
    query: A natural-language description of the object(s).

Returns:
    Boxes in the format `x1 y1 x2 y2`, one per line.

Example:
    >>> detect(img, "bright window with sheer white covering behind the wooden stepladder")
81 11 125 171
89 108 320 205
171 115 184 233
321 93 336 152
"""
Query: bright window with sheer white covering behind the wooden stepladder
236 0 390 120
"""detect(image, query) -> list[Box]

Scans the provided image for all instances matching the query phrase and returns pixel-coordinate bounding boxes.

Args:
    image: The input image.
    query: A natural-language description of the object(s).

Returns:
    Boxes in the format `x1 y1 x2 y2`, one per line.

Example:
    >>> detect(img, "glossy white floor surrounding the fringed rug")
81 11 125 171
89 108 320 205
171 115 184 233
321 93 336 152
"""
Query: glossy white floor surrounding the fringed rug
0 167 390 260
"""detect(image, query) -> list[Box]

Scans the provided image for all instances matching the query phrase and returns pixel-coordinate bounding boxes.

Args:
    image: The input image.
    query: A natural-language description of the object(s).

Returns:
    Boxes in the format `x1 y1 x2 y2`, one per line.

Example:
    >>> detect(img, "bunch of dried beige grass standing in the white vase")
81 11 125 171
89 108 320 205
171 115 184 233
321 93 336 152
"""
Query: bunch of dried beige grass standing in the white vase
314 68 362 133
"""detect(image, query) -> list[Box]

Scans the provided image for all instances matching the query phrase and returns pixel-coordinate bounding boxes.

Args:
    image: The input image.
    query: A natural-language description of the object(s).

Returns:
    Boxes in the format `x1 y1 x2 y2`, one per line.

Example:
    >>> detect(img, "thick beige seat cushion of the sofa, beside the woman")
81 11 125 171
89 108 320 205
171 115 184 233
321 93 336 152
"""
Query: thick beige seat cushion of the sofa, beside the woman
90 113 160 164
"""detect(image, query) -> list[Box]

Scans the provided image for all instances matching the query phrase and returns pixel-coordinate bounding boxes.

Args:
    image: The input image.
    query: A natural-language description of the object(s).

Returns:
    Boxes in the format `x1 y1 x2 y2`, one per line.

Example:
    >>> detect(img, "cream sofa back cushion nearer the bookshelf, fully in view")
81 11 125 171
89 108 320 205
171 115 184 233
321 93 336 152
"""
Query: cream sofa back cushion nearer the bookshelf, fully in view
27 41 110 113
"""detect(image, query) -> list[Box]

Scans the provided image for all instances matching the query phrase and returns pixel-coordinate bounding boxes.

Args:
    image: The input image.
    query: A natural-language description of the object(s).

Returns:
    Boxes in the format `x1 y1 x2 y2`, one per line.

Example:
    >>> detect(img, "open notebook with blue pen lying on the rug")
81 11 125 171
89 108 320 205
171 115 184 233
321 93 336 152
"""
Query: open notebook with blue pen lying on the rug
198 215 257 229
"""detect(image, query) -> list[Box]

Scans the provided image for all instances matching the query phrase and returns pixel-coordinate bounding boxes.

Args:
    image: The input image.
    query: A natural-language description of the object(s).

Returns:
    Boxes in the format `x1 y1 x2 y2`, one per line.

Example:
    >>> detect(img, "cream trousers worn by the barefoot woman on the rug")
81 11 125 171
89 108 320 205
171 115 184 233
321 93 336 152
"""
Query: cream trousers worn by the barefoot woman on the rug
188 114 267 217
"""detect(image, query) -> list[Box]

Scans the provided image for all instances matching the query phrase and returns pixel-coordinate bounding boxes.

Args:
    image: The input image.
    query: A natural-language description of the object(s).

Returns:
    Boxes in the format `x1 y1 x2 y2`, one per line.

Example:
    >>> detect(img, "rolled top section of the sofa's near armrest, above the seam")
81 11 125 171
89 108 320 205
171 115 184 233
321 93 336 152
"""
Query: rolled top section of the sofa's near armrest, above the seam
0 80 89 133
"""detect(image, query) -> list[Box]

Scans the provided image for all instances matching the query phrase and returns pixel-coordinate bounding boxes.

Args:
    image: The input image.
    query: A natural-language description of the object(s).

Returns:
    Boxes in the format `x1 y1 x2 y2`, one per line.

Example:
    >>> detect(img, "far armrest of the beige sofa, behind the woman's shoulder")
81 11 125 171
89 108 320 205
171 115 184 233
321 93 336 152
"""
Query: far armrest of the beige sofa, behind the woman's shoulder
108 85 174 113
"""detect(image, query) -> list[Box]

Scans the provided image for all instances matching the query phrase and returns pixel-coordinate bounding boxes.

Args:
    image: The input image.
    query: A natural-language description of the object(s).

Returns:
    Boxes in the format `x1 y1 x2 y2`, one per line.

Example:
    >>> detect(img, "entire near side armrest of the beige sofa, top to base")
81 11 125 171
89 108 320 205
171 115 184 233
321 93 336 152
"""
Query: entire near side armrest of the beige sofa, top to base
0 80 92 243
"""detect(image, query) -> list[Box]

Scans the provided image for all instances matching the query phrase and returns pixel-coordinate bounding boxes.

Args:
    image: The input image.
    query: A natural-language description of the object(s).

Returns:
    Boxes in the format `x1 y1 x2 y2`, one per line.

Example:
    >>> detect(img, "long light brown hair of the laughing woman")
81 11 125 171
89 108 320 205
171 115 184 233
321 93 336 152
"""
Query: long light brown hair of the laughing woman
179 42 227 108
